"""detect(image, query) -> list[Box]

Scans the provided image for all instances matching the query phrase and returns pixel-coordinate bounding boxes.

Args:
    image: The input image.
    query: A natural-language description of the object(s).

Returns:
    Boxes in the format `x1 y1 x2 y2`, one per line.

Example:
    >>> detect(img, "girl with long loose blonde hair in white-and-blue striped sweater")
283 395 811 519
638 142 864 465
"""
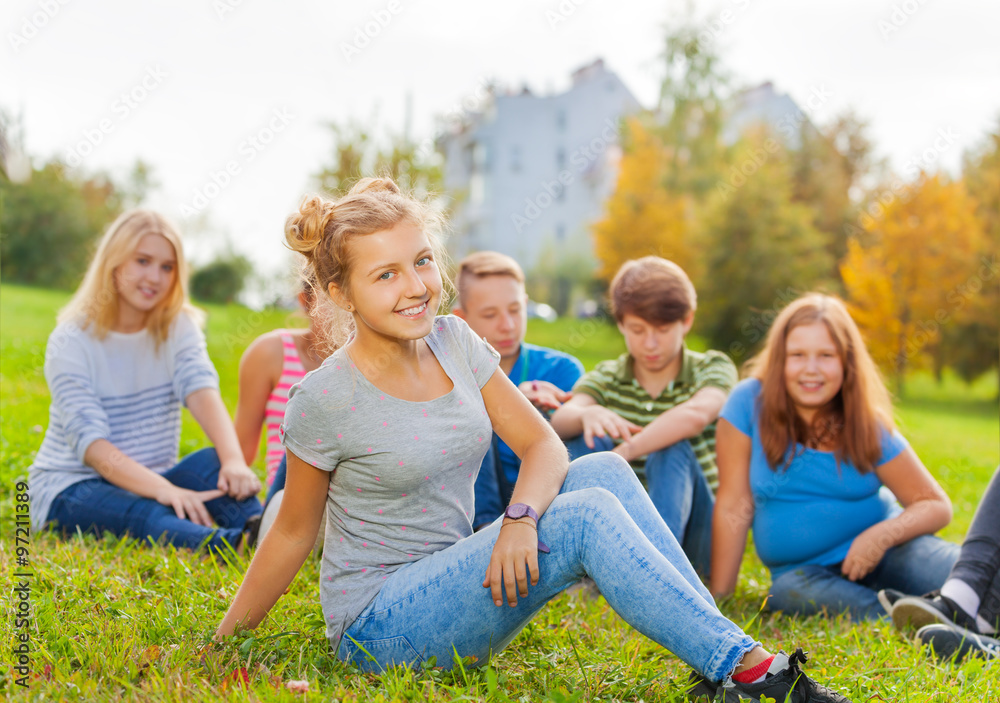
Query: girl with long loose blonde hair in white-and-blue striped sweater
29 210 260 550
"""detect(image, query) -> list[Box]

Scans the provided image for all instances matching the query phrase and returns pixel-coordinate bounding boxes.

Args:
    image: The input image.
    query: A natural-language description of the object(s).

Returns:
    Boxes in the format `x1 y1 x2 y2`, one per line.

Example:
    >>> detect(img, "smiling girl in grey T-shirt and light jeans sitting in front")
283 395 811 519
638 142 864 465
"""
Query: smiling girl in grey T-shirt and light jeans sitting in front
217 179 845 702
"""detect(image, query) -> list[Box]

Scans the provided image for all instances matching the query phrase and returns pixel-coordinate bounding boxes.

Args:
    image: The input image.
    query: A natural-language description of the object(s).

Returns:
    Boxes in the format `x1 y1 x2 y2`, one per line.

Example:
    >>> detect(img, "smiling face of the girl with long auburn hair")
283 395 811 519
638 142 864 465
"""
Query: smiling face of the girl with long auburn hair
785 321 844 421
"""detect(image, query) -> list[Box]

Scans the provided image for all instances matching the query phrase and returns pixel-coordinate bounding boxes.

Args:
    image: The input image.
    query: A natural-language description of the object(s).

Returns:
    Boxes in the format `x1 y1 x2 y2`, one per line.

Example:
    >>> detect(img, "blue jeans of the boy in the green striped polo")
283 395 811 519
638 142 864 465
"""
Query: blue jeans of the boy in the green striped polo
566 435 715 579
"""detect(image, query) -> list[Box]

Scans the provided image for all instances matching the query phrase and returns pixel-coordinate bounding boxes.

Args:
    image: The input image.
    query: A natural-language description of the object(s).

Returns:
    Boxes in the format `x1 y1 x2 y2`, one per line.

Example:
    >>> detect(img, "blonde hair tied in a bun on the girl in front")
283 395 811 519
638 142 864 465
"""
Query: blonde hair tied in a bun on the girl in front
285 178 452 352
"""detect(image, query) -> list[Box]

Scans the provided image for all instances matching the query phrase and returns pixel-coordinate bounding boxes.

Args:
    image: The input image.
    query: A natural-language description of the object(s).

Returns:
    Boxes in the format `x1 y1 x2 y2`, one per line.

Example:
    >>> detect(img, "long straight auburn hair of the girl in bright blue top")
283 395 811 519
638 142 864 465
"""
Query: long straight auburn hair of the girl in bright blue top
747 293 894 473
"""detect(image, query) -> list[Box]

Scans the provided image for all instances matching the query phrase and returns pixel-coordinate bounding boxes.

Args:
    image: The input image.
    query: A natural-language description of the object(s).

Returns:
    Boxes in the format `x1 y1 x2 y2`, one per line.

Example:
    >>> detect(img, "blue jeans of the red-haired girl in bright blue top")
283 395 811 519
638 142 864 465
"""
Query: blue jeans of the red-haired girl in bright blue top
768 535 959 620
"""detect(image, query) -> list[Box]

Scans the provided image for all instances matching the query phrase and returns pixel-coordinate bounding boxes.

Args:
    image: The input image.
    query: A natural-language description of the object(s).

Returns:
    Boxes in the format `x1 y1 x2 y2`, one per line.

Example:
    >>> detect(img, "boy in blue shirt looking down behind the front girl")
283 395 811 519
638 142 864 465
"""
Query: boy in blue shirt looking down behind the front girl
452 251 583 529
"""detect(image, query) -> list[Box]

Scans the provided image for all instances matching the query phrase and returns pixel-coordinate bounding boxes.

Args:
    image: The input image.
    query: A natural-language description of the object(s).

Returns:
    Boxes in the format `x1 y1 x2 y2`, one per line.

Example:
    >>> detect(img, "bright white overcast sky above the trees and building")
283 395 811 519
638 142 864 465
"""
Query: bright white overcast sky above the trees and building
0 0 1000 290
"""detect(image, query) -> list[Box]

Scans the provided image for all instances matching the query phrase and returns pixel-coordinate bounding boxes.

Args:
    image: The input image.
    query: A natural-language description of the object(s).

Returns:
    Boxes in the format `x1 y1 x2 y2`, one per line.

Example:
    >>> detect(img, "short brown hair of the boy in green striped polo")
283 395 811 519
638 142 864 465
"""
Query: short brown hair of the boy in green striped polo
610 256 698 325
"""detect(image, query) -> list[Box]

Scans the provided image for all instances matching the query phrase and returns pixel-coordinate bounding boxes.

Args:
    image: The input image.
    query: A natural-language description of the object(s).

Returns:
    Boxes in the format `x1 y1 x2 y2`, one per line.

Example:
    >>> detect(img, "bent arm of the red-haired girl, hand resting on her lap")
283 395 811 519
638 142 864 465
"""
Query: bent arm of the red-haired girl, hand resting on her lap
841 447 952 581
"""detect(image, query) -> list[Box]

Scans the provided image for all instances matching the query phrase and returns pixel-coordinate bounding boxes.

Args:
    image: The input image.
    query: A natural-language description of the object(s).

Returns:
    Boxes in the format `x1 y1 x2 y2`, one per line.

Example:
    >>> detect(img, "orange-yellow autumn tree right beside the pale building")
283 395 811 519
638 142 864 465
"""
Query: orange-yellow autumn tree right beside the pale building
593 118 694 280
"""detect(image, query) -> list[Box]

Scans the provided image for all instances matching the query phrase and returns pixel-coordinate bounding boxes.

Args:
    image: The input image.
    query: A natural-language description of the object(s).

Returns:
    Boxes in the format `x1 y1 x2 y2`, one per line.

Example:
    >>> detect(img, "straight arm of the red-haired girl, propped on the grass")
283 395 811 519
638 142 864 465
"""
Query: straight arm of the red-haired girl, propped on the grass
709 419 754 596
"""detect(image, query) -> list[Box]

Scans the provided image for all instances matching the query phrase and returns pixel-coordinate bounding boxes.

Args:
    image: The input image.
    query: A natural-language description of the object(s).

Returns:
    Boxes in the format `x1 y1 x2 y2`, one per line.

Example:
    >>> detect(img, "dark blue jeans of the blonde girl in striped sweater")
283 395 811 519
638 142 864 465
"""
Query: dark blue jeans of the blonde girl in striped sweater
48 448 261 551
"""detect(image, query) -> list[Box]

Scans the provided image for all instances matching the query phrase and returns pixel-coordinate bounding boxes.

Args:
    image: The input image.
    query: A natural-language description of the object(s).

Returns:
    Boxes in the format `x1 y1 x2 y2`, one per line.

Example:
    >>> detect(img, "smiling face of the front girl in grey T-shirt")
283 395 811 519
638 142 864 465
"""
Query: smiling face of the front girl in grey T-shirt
340 221 442 340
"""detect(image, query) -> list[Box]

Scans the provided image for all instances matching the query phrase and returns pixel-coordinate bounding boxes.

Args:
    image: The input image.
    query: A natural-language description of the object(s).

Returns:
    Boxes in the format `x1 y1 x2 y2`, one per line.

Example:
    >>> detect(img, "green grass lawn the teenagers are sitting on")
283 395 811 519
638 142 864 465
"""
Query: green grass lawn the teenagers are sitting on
0 285 1000 702
